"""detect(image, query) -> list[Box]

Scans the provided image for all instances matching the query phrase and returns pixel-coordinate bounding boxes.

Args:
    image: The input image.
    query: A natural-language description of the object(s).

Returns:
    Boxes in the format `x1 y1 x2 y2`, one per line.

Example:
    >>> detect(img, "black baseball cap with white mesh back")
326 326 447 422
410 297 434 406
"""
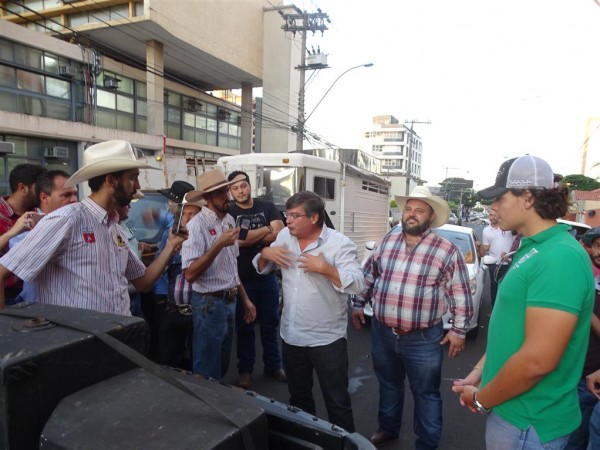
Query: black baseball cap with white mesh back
477 155 554 200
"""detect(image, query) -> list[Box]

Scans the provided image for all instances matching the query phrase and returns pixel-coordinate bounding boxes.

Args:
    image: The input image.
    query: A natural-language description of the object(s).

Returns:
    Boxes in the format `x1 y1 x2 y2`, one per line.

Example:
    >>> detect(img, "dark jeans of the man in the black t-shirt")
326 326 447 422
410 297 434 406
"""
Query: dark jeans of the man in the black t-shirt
235 273 281 373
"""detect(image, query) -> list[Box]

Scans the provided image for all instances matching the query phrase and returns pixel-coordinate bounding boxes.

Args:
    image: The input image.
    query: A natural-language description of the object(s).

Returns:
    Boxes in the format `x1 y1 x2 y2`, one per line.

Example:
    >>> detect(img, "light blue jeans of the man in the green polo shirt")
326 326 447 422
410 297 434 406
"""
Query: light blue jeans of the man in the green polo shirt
485 412 569 450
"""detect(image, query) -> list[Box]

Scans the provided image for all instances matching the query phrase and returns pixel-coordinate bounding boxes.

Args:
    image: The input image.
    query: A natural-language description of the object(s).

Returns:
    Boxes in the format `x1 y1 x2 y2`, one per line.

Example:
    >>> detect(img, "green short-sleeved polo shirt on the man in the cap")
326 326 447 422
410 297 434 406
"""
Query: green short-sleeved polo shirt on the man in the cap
482 225 594 442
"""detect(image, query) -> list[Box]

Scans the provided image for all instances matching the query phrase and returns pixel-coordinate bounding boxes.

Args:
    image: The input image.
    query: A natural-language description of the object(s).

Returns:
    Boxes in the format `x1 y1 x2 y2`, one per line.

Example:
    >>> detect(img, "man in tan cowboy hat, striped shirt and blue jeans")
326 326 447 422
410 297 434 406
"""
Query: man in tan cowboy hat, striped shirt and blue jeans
181 169 256 380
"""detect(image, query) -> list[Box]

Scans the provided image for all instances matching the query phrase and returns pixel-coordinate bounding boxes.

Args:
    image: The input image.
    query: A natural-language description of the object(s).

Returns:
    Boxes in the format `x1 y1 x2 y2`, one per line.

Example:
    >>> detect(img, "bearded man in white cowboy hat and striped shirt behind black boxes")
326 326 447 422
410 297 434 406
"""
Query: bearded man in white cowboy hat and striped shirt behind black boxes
0 141 185 315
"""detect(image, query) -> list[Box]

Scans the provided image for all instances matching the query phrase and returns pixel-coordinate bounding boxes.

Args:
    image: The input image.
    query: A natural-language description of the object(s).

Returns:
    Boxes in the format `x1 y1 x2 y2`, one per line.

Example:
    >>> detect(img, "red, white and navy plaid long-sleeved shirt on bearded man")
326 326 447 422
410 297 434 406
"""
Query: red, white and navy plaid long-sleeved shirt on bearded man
354 227 473 336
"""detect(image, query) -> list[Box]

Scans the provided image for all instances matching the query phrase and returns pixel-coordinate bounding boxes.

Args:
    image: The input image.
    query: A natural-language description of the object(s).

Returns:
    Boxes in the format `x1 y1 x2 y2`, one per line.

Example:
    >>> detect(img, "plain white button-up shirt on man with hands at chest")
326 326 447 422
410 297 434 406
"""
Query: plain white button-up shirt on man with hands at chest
253 226 364 347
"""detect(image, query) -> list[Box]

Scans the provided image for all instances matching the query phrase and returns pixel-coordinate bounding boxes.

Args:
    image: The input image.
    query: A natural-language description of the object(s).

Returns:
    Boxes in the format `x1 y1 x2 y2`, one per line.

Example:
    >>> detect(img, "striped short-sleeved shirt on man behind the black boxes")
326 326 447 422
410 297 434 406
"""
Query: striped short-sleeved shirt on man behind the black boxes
0 198 146 316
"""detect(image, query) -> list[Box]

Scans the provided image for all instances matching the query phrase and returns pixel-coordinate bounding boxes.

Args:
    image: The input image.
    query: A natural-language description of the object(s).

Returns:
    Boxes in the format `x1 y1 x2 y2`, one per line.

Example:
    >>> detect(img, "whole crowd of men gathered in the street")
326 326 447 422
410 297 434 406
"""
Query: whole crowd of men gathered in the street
0 141 600 450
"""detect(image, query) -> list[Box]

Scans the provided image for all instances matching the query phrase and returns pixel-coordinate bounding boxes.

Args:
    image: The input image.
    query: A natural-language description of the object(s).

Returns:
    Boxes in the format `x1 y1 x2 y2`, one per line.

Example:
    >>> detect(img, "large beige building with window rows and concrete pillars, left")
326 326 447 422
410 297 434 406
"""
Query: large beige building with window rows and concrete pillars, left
0 0 297 195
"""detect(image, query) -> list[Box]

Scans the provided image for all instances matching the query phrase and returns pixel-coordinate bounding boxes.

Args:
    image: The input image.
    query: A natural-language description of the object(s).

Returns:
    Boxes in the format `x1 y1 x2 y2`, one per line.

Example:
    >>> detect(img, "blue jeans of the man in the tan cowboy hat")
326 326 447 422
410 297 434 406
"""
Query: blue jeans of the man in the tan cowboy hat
192 291 235 380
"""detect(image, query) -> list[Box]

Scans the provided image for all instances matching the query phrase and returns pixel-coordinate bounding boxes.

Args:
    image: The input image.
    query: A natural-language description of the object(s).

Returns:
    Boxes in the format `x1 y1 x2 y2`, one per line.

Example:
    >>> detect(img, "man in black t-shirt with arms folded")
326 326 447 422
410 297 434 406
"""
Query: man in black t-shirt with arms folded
228 171 287 389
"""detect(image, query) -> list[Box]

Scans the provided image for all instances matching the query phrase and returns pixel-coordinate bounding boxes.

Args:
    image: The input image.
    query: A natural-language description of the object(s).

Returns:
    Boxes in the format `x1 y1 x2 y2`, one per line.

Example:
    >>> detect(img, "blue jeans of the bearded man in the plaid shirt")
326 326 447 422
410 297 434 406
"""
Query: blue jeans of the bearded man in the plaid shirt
371 318 443 450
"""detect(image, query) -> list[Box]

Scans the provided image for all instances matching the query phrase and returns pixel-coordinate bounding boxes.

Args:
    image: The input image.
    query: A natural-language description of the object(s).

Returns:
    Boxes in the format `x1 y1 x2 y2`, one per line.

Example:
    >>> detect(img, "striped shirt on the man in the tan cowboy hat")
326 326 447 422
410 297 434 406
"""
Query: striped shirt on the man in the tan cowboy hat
181 208 240 293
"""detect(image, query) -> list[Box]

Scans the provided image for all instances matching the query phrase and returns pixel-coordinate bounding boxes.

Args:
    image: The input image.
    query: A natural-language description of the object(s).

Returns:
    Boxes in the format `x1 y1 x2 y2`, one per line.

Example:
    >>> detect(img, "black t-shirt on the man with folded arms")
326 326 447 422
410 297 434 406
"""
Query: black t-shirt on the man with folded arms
229 200 281 278
